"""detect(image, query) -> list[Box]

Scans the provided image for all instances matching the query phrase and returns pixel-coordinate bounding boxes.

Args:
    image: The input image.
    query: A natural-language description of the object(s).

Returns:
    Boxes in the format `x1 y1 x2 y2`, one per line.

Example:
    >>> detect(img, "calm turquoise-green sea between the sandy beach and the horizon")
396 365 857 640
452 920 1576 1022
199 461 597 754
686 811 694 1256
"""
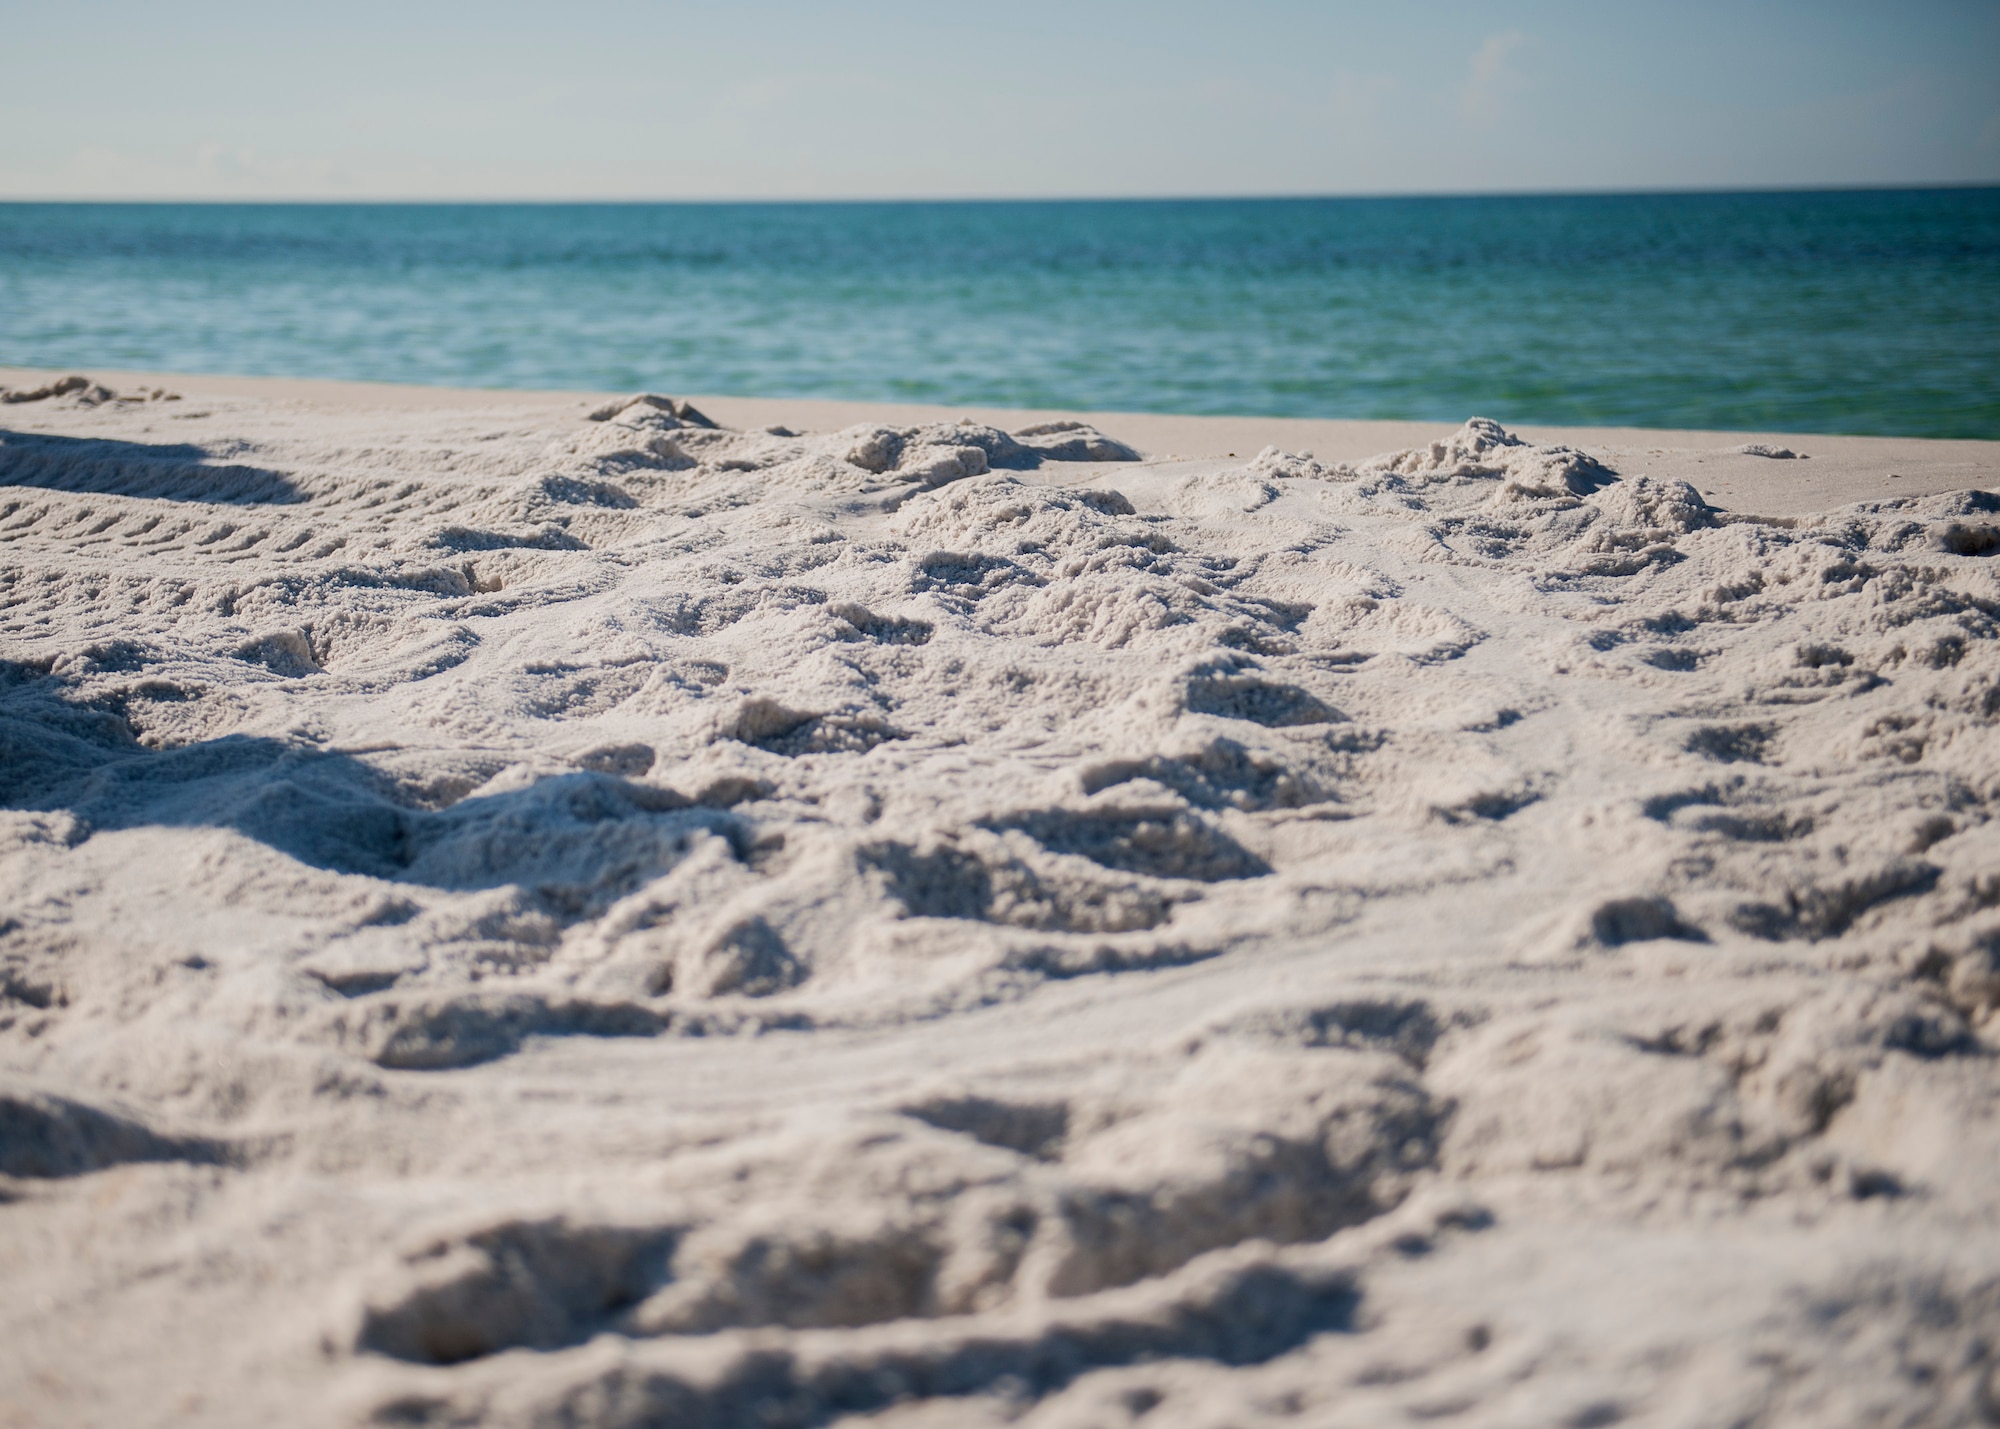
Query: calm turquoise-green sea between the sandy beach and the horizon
0 188 2000 438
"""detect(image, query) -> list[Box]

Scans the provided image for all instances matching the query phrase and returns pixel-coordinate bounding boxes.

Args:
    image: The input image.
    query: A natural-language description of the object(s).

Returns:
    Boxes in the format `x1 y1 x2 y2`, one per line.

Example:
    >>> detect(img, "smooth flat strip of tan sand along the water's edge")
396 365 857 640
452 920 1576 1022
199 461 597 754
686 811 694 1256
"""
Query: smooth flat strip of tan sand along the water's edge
0 366 2000 516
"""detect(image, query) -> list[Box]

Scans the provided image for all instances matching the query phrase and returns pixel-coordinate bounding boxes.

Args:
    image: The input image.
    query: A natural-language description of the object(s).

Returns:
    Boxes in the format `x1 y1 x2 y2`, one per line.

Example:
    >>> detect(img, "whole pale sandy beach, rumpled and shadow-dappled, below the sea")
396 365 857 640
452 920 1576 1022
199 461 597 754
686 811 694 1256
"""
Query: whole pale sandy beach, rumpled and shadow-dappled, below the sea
0 374 2000 1429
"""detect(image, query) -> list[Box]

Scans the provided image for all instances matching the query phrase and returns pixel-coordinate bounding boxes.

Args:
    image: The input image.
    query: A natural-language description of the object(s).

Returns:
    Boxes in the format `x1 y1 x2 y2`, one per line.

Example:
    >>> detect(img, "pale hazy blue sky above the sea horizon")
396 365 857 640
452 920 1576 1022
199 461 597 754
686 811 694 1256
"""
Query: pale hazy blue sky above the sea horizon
0 0 2000 200
